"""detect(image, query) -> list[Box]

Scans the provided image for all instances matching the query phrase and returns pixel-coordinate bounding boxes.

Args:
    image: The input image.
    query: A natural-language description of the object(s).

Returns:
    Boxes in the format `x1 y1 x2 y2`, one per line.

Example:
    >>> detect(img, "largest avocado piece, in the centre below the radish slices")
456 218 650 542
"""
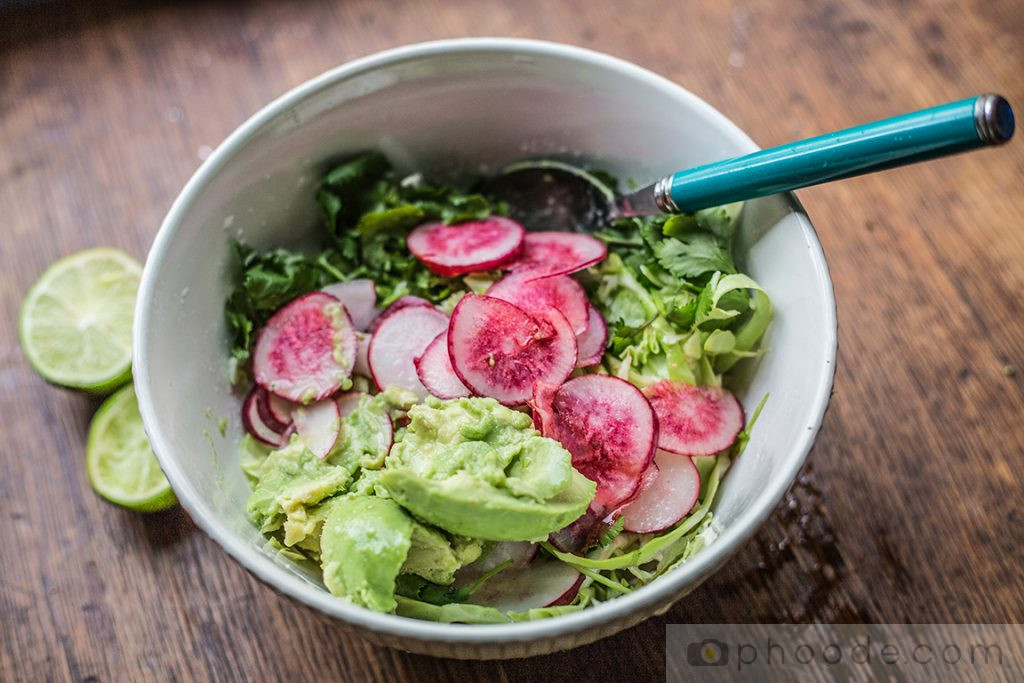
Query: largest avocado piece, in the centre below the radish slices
380 398 595 541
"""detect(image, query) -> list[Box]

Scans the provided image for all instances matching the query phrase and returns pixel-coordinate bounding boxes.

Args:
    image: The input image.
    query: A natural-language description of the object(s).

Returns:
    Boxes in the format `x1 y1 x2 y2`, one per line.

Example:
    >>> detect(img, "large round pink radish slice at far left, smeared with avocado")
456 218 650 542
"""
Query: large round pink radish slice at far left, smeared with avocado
253 292 356 402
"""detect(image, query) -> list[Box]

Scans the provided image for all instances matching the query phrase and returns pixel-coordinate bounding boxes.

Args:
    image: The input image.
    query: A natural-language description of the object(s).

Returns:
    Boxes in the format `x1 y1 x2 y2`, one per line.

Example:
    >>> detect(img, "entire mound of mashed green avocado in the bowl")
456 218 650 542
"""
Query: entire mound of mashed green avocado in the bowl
240 389 595 611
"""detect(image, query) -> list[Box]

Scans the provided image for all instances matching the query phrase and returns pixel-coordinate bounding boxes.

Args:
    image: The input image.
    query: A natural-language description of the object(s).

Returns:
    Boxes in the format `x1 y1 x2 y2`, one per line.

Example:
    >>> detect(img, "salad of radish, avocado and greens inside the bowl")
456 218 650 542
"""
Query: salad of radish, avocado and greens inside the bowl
225 152 771 623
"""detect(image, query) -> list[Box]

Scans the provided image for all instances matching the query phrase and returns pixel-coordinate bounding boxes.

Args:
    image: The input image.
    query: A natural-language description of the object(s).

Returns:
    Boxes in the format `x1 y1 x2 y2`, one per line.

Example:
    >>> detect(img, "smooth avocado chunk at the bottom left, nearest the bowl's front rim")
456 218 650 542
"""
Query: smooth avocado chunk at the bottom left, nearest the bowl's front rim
321 496 414 612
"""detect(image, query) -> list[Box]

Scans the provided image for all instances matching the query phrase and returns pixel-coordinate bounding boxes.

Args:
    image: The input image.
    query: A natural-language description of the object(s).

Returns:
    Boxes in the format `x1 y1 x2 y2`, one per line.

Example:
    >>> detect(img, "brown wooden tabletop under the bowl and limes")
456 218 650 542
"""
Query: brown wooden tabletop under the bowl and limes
0 0 1024 681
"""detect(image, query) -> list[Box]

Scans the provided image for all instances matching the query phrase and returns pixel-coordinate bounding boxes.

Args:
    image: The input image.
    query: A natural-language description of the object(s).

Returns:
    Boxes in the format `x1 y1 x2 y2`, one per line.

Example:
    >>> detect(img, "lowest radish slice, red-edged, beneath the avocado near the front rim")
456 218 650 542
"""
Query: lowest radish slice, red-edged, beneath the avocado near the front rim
456 557 583 612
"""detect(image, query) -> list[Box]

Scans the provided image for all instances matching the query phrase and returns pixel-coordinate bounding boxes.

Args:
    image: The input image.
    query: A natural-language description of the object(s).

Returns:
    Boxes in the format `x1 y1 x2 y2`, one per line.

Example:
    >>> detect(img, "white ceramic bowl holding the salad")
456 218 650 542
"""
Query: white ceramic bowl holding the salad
134 39 836 658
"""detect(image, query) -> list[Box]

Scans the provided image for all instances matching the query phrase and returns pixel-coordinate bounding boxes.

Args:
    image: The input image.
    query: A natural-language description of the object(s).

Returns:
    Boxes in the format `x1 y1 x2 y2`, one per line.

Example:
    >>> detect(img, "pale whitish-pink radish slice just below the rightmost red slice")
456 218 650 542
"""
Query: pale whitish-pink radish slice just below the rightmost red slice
623 450 700 533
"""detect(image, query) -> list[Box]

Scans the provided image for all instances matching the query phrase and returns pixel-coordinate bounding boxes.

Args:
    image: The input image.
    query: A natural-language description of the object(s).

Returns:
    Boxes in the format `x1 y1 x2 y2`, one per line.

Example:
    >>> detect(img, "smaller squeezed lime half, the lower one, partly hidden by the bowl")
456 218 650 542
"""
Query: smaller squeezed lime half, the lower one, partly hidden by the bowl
85 384 177 512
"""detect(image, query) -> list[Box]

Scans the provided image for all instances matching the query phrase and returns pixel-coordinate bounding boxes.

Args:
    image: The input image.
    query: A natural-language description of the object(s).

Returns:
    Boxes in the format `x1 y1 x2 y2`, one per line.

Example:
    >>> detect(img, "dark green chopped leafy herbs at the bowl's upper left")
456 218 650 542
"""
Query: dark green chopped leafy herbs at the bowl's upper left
224 152 507 364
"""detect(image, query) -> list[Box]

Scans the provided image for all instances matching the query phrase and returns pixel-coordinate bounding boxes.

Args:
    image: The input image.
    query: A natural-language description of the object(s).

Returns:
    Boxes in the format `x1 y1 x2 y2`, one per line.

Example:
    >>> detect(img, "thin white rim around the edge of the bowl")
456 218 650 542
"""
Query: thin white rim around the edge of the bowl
132 38 837 645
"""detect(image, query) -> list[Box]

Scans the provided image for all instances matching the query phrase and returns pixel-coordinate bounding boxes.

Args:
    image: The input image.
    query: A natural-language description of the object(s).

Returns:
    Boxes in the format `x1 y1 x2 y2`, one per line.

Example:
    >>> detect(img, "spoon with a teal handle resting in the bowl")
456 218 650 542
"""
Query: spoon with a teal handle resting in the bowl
482 94 1014 231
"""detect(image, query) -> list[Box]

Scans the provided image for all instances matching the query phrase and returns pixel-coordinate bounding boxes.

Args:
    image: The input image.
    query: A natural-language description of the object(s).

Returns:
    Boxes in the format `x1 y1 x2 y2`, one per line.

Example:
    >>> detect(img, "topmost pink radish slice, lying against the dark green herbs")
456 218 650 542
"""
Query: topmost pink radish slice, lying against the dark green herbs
406 216 526 278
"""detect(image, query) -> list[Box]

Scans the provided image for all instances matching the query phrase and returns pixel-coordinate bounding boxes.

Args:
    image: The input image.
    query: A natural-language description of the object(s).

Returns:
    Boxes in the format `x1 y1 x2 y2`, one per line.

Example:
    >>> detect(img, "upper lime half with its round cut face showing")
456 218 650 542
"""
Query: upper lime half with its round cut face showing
18 248 142 393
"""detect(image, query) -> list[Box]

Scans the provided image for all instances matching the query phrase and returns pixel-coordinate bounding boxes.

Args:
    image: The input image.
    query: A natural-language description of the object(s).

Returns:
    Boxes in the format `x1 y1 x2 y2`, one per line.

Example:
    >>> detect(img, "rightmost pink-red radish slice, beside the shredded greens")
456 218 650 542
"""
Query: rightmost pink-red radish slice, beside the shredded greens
643 380 743 456
